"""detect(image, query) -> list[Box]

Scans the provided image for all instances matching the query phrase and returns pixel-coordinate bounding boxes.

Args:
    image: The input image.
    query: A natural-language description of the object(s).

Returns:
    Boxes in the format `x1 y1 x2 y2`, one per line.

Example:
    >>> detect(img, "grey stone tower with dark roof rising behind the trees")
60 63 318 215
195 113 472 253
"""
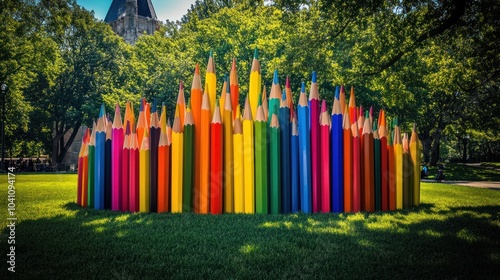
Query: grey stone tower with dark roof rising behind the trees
104 0 160 45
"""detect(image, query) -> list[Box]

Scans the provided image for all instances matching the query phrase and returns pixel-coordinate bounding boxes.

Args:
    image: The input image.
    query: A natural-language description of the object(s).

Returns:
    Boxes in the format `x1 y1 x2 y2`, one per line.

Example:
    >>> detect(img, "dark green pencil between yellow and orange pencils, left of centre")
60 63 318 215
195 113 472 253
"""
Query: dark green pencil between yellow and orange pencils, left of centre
182 106 194 212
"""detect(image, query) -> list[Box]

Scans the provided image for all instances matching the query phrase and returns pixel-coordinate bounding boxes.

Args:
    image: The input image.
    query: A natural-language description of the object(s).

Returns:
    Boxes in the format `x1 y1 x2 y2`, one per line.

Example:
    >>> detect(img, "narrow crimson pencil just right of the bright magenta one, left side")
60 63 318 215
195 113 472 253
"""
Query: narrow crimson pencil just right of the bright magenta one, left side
122 121 132 211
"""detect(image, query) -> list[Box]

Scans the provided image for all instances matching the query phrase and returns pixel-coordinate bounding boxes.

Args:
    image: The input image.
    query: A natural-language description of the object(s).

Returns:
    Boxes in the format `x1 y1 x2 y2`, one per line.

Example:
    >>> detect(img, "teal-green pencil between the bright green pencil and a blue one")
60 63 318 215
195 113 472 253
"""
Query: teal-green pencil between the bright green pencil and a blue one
269 110 281 214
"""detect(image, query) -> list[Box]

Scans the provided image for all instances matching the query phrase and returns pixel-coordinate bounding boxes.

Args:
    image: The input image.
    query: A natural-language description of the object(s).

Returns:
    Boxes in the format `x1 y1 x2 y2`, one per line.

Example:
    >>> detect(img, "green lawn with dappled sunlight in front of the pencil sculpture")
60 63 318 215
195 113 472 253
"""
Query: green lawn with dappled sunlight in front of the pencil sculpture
0 174 500 279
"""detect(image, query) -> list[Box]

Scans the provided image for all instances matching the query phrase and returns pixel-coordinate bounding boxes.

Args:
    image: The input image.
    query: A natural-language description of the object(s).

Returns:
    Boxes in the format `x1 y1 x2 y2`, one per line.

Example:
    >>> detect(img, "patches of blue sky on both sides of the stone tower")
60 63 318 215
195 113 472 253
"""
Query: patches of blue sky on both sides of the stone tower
76 0 195 22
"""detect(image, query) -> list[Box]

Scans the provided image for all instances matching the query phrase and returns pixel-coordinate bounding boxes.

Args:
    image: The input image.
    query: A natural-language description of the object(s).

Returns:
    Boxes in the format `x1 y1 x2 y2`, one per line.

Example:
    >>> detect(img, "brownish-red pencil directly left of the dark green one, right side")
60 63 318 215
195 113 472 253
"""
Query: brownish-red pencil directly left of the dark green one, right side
361 118 375 212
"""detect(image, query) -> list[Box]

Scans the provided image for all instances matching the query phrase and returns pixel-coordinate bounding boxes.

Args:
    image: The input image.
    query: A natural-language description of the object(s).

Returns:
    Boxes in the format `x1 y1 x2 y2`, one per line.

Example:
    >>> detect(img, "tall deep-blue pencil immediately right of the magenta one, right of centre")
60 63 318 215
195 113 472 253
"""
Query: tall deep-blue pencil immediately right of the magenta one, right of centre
332 87 344 213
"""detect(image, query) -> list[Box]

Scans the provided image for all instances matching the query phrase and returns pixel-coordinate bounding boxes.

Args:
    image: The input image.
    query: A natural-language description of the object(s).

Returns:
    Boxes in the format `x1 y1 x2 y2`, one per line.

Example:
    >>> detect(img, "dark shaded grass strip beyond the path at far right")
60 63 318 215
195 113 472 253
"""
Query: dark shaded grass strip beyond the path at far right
429 163 500 181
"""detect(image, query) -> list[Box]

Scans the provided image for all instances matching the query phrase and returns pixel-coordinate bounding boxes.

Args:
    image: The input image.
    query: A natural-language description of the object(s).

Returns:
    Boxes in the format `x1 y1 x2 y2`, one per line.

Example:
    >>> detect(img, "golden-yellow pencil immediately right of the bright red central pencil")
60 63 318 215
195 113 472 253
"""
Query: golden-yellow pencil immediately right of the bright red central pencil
222 81 234 213
